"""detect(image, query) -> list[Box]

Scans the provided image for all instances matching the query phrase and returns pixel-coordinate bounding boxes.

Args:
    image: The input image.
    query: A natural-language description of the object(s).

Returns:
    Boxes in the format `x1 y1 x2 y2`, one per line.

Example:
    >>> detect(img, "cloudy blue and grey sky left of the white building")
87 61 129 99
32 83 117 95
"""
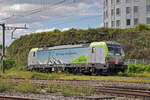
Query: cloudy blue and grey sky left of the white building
0 0 103 46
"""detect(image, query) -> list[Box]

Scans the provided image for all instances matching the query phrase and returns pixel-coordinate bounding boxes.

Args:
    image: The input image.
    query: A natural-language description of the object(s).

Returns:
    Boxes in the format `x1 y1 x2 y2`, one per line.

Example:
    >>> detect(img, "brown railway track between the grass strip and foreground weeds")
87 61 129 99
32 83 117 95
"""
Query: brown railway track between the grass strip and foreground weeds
9 78 150 91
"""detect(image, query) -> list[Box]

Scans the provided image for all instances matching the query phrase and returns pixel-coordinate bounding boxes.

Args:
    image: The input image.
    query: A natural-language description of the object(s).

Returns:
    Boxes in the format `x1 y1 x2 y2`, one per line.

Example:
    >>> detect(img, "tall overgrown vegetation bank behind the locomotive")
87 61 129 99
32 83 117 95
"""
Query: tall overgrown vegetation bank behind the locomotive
7 24 150 65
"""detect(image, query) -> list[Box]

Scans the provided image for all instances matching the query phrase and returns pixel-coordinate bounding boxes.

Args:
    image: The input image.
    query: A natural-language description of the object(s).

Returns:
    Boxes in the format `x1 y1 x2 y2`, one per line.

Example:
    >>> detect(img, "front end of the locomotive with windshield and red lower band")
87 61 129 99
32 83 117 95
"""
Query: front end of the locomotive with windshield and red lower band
106 42 127 73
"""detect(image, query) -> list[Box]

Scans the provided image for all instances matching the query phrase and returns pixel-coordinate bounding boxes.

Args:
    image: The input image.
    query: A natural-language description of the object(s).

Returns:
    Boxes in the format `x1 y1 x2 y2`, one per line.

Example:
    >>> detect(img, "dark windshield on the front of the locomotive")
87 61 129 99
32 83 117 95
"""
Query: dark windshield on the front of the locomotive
108 45 123 55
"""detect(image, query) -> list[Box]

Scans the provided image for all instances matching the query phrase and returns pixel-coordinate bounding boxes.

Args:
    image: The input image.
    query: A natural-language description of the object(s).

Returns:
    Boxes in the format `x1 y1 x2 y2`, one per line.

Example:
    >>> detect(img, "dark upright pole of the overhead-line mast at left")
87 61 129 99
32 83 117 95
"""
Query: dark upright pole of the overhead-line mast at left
2 24 5 73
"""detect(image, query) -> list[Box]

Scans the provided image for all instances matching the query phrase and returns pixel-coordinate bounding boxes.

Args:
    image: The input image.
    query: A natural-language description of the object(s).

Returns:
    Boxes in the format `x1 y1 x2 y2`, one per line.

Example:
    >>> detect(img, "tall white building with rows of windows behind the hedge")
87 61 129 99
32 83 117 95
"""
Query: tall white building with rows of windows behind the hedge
104 0 150 28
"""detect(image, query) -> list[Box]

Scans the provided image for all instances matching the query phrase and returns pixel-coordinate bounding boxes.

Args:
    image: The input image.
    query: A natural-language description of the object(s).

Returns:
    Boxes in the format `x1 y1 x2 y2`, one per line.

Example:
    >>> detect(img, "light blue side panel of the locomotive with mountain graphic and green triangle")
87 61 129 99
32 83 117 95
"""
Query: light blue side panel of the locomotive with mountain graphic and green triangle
37 48 88 65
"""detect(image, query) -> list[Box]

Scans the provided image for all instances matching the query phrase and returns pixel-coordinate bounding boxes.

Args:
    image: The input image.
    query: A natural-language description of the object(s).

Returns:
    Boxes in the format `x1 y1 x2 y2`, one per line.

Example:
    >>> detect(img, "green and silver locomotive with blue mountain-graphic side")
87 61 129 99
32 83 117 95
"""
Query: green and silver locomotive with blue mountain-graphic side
28 42 127 75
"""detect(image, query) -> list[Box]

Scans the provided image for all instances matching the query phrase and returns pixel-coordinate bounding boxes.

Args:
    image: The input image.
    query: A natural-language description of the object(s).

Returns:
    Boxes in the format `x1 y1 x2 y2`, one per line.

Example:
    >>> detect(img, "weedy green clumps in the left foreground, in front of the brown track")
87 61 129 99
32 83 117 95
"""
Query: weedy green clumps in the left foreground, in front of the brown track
0 79 94 96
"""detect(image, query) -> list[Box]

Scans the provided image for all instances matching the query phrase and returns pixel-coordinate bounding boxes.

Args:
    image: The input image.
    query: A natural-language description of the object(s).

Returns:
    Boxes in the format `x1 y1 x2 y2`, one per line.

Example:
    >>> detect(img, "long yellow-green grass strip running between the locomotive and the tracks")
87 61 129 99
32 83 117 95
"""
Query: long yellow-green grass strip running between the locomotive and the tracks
0 70 150 82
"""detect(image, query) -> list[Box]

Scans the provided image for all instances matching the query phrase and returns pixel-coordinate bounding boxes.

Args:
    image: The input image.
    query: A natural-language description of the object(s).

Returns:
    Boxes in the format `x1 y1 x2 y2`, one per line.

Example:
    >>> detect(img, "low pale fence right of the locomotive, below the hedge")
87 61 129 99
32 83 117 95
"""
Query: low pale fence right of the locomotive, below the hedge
125 59 150 65
